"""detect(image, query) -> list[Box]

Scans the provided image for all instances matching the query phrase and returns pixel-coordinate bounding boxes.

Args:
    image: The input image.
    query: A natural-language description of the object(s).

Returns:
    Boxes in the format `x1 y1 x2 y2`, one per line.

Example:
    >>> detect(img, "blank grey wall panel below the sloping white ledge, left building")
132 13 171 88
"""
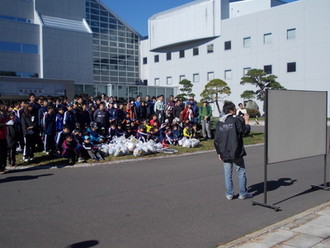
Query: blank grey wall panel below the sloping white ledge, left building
43 27 93 84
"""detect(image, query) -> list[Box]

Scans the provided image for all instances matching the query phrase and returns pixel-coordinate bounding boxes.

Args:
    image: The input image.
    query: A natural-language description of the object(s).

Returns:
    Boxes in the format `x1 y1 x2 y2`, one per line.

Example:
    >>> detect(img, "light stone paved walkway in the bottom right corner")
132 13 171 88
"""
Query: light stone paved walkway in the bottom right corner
217 201 330 248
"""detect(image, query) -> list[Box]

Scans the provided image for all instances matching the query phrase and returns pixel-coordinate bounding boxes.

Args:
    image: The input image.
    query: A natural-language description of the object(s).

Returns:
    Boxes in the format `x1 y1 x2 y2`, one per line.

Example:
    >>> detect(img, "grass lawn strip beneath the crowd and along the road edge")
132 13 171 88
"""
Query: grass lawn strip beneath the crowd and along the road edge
12 132 264 170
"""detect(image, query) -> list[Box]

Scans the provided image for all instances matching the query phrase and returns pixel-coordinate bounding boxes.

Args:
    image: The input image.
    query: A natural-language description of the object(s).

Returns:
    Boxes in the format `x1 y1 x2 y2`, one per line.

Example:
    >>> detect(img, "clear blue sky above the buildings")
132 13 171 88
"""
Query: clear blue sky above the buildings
102 0 296 36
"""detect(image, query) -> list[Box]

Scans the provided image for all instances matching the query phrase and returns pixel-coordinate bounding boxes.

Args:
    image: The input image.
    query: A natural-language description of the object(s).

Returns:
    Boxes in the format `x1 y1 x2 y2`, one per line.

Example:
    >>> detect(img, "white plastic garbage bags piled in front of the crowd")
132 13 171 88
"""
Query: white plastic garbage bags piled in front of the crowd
100 136 200 157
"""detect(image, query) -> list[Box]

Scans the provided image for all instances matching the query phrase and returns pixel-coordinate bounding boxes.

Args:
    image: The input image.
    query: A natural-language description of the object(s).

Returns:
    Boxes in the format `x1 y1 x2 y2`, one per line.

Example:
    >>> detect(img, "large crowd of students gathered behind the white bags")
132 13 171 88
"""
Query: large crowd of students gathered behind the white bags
0 93 212 171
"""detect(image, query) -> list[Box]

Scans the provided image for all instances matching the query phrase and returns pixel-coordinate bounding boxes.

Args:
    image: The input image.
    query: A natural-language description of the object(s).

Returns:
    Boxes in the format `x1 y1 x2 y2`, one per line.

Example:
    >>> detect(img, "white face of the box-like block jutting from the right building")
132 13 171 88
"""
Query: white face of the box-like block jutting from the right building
149 0 221 50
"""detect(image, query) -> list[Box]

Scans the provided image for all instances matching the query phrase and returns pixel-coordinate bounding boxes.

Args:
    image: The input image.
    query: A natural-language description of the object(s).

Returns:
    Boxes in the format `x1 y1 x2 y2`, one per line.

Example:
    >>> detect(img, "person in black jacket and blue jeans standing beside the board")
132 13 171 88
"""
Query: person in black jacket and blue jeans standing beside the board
214 102 252 200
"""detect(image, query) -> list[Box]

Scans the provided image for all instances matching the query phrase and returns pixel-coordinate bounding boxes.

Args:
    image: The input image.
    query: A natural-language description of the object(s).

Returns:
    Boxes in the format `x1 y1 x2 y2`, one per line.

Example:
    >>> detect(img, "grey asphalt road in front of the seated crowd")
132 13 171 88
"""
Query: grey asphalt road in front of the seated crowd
0 145 330 248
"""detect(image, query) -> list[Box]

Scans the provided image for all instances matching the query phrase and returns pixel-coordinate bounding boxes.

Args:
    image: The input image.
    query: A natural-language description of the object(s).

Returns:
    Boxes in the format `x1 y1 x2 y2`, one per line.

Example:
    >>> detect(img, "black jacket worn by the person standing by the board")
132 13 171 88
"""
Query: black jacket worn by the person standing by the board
214 114 251 161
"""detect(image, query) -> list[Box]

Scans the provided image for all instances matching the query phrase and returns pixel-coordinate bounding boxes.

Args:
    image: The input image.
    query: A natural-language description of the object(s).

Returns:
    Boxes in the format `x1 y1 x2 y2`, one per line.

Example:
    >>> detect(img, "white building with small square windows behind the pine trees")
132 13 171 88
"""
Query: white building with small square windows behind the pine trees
140 0 330 114
